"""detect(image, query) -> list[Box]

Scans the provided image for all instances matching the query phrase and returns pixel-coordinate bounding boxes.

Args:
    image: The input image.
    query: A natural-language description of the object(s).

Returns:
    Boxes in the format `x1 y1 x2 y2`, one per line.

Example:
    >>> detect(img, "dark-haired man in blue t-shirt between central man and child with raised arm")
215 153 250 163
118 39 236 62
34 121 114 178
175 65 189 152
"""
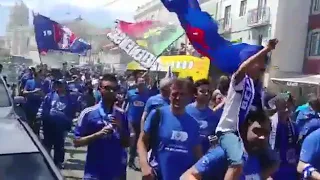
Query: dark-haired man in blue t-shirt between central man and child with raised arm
186 79 220 153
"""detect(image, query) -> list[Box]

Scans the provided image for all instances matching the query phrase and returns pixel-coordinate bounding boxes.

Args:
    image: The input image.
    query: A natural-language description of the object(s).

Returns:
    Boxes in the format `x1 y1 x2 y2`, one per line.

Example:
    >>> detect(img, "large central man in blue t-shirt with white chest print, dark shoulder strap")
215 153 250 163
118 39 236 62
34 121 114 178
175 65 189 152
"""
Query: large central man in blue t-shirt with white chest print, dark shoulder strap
138 79 202 180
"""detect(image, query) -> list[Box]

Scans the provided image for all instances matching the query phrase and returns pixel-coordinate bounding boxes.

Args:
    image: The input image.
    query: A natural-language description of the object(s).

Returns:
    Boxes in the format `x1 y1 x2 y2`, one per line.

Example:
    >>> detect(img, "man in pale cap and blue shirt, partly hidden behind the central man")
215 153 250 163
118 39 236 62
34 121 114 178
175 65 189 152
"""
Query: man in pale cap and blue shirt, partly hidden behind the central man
141 78 172 129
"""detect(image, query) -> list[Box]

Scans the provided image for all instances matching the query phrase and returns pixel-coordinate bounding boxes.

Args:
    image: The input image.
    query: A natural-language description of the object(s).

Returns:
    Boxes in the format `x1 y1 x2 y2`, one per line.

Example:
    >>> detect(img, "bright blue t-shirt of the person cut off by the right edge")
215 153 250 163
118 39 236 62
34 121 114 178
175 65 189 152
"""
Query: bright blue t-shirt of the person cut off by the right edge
300 129 320 170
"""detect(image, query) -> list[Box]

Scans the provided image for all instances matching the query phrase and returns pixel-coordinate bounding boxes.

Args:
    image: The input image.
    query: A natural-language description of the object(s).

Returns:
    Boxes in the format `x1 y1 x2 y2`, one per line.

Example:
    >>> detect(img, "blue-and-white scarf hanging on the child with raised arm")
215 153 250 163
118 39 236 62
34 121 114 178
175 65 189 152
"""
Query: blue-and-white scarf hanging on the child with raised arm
239 75 255 125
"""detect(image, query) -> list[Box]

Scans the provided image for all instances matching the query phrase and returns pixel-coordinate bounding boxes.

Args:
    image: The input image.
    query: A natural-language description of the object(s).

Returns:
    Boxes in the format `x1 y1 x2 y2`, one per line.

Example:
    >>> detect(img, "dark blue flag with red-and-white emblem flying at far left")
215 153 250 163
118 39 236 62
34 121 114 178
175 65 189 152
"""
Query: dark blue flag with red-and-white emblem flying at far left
33 14 91 55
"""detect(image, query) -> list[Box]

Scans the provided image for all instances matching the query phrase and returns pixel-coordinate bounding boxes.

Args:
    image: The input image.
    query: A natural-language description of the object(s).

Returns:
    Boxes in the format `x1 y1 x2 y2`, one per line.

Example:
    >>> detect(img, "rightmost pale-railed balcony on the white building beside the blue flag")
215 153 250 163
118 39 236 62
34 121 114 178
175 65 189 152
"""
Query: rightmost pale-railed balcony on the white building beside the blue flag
247 7 270 27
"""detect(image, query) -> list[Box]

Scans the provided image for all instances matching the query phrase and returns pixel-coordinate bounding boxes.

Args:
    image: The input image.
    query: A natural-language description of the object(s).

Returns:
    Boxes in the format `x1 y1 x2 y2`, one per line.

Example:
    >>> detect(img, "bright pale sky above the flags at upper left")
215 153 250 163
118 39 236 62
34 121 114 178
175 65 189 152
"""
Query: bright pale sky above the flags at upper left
0 0 151 35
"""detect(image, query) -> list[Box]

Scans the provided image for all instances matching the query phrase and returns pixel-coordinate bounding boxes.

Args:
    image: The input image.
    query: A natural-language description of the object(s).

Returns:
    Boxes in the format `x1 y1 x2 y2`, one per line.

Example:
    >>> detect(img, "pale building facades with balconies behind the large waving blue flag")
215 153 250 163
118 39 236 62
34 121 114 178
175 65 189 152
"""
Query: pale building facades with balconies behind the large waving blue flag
135 0 320 84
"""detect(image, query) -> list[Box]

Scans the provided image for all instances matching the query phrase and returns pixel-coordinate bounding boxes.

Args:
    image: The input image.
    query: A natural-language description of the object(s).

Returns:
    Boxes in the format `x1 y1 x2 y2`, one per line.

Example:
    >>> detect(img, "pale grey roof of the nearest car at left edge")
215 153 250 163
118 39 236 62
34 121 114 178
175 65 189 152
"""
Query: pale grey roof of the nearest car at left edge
0 118 39 155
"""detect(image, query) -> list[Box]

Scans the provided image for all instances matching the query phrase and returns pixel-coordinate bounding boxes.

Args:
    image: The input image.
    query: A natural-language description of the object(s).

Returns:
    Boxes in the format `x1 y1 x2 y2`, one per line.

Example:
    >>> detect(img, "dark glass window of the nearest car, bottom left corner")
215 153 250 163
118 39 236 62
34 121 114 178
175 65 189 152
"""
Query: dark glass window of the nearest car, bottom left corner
0 153 57 180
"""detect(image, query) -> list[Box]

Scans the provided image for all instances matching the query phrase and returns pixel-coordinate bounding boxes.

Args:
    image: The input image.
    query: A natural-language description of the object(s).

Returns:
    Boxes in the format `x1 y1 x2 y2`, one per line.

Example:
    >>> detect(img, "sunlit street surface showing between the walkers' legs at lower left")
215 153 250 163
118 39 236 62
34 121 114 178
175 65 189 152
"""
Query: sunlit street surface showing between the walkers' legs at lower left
62 133 141 180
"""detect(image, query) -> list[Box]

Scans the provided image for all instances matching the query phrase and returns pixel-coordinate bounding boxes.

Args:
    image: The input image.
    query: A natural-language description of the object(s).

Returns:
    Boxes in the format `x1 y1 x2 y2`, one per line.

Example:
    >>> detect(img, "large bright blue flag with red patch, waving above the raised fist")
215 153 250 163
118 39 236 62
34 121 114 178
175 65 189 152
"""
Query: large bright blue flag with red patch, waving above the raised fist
161 0 263 74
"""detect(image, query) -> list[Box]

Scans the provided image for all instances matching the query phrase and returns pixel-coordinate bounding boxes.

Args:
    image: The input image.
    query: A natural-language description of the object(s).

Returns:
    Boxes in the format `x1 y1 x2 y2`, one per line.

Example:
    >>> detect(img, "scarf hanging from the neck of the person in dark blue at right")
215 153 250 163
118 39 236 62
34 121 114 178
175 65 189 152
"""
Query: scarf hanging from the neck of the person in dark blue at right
269 113 296 164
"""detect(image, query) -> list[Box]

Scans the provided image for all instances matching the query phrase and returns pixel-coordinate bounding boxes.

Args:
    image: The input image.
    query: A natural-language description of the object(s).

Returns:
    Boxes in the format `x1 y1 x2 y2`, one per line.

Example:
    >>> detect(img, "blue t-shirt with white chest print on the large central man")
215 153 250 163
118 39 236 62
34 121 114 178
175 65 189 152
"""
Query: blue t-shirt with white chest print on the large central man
144 106 200 180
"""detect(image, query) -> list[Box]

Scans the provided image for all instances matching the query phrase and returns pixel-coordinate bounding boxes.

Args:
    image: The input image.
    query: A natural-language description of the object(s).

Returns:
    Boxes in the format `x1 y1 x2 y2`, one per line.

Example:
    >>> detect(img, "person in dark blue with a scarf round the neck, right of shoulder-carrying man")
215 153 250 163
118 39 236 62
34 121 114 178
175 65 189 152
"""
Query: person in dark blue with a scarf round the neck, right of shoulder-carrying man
269 93 299 180
